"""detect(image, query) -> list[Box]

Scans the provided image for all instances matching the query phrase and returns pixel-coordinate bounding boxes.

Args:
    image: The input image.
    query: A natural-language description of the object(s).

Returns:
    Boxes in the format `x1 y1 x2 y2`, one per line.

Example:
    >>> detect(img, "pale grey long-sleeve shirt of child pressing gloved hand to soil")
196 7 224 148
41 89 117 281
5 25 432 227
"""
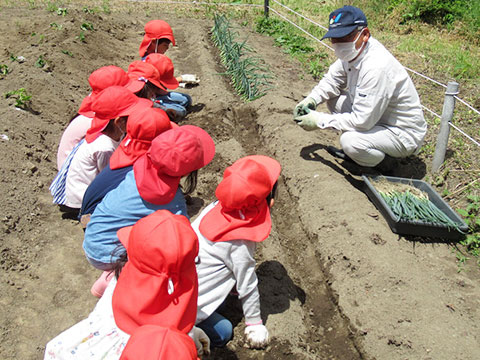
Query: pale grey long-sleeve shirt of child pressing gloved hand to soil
192 202 261 324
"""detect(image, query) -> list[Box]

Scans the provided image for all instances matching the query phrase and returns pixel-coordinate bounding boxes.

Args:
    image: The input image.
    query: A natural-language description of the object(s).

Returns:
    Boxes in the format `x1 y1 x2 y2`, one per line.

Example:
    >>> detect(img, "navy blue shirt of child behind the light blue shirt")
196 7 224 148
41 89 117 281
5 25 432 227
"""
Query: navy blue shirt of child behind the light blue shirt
78 164 133 219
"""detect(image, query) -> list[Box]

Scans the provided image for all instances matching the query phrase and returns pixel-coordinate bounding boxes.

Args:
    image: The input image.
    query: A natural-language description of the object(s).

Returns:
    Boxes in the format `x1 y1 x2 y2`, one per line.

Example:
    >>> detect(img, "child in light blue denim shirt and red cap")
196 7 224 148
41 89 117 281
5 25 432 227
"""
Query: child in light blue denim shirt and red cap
83 125 215 270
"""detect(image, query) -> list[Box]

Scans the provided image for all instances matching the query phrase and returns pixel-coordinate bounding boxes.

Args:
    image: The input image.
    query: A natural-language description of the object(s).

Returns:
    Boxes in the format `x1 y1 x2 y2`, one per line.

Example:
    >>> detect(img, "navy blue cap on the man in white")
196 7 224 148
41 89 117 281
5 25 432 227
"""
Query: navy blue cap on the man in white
322 5 367 40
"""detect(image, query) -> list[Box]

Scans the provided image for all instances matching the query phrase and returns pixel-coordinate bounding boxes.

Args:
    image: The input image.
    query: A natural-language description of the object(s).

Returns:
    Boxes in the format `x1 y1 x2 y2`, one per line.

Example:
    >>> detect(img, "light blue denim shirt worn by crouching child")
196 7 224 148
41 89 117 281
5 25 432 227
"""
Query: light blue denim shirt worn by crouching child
83 170 188 264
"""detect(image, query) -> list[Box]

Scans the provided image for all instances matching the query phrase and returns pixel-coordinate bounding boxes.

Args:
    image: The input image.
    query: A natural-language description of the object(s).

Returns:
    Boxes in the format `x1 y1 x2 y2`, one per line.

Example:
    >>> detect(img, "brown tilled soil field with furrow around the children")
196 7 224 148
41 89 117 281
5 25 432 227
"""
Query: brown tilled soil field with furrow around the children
0 2 480 360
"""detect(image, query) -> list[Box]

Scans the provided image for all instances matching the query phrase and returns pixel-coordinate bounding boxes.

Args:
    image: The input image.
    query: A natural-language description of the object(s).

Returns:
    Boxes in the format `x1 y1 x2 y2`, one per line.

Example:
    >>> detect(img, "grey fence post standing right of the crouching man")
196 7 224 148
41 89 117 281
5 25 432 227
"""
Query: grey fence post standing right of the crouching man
432 81 458 173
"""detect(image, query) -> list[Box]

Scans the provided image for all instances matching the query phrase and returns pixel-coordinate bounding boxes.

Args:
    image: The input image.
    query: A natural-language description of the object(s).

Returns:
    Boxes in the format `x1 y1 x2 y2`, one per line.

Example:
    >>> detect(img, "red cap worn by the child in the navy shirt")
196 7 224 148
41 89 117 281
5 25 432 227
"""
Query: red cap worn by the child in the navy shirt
110 108 172 170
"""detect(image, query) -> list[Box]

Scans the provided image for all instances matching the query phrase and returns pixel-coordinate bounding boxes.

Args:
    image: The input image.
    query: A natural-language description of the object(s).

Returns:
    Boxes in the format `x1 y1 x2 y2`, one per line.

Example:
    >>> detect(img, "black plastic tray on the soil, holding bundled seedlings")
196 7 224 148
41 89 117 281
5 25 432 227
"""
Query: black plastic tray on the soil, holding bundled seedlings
362 175 468 240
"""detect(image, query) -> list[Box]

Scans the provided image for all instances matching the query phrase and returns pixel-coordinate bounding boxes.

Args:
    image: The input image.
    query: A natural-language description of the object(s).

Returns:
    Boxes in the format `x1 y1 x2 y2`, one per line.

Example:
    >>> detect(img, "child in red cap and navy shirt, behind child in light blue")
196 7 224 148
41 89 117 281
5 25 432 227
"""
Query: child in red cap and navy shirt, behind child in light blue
79 108 177 227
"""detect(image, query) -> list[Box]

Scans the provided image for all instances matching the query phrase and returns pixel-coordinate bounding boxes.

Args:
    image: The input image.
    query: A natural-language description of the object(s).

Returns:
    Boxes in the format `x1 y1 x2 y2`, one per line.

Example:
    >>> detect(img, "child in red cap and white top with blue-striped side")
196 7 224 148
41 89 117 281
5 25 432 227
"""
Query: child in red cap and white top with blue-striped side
50 86 152 214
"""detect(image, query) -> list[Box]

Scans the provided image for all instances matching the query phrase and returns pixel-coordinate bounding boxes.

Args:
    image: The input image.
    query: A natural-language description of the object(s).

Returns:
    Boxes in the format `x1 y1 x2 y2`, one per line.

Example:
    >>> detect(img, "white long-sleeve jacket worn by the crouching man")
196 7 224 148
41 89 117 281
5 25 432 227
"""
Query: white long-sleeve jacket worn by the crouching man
309 37 427 149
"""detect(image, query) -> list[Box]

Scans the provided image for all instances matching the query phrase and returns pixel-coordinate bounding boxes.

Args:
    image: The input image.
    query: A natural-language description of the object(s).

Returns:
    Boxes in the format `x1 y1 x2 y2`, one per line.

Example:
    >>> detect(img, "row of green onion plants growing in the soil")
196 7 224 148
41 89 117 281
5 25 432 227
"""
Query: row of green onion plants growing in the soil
212 14 271 101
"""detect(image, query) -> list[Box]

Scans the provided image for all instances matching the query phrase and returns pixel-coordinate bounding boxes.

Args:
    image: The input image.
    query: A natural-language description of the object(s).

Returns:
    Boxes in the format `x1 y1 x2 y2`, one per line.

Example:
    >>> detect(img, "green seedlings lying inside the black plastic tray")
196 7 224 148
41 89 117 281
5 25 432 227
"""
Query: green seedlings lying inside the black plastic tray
379 184 463 233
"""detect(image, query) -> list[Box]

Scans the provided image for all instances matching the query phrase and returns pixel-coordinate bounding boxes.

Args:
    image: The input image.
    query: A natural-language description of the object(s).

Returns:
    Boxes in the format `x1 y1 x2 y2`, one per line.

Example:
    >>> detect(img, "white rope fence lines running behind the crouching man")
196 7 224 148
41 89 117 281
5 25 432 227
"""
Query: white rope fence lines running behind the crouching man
128 0 480 147
